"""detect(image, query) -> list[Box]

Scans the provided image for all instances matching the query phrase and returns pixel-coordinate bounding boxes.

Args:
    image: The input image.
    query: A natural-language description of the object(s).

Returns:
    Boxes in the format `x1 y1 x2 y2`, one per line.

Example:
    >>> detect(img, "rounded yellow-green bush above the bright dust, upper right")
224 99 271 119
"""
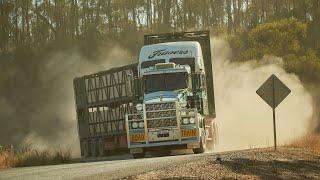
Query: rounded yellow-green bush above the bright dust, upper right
248 19 307 56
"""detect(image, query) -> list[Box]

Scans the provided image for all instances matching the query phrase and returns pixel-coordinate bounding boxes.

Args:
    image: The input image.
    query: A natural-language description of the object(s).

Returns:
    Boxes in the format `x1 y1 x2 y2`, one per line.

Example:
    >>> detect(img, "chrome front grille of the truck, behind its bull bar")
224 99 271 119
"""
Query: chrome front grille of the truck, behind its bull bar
146 102 177 128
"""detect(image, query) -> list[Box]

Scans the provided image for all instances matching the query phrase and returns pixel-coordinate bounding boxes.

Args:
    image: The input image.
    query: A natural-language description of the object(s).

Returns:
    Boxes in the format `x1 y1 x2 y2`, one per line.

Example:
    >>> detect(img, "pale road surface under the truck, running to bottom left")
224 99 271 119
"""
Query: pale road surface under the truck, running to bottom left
0 151 203 180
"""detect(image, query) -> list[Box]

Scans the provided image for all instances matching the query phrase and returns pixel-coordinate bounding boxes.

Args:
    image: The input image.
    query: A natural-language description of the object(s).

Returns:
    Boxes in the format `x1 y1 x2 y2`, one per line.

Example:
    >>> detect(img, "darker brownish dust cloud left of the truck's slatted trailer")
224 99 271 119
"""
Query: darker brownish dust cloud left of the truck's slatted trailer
0 46 132 157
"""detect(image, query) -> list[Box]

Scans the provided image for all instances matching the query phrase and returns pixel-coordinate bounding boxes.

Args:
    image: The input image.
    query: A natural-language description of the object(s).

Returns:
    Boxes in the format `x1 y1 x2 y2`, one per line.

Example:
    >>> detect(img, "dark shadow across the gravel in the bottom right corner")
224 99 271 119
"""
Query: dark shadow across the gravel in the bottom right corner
214 158 320 179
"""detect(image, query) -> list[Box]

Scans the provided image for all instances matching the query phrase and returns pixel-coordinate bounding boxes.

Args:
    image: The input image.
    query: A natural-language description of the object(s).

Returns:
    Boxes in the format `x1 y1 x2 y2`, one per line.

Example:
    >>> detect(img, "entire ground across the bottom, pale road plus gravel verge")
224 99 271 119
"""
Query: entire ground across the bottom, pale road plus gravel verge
0 148 320 179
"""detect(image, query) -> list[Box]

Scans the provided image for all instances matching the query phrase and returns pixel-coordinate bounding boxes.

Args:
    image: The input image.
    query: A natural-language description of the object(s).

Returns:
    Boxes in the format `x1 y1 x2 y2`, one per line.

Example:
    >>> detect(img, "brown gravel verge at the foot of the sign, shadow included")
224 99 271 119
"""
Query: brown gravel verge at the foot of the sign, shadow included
125 148 320 179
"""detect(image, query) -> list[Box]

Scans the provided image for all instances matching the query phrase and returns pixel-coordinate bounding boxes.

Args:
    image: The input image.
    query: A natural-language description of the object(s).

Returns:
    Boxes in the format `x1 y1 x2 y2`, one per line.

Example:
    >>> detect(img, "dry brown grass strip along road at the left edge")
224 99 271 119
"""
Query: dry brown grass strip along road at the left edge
0 146 71 169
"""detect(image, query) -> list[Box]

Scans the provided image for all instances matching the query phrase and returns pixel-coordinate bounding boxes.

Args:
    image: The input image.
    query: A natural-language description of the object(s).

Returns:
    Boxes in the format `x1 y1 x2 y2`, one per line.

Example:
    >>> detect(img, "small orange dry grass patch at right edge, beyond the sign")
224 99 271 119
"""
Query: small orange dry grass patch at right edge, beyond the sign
287 134 320 153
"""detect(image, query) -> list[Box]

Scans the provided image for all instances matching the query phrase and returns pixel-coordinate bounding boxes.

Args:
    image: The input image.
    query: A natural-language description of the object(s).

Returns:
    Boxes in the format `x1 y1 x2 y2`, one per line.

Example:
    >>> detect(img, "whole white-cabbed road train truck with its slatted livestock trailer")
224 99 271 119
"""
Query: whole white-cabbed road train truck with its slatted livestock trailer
73 31 217 158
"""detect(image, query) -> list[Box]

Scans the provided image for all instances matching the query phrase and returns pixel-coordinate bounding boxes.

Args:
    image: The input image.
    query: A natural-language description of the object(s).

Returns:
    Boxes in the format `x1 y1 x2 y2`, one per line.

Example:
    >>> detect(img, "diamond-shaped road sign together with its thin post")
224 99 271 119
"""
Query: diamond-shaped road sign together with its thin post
256 74 291 150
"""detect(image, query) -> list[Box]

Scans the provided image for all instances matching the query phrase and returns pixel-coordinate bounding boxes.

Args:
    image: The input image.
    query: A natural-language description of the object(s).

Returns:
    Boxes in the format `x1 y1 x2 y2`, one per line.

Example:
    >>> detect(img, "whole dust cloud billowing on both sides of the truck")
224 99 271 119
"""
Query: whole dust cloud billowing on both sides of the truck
0 35 313 156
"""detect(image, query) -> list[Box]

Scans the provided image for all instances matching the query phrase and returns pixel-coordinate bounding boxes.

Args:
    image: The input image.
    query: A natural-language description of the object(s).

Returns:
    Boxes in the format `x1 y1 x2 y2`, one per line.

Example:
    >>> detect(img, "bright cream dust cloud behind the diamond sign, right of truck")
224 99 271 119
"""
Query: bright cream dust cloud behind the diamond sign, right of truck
211 38 313 151
